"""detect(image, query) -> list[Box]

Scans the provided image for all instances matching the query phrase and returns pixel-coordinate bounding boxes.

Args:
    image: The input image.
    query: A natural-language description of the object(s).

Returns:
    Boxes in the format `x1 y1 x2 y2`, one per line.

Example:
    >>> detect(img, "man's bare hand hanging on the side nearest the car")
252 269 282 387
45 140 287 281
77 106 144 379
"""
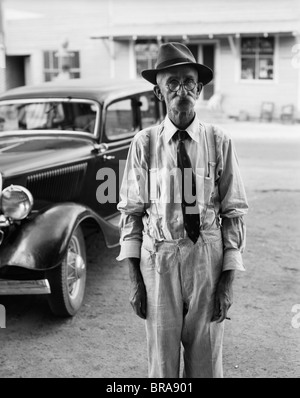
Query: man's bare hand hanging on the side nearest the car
128 258 147 319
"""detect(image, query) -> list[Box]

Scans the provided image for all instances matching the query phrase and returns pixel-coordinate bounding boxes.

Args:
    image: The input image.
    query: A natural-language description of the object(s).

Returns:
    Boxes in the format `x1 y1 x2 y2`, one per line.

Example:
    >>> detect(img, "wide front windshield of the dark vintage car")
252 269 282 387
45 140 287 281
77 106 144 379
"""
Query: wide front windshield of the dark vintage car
0 99 99 134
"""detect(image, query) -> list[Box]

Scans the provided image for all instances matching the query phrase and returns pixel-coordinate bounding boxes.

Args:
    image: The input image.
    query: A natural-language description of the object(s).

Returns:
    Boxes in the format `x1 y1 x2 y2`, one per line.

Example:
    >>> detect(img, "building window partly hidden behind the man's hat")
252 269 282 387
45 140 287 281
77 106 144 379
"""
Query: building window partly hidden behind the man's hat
135 40 158 76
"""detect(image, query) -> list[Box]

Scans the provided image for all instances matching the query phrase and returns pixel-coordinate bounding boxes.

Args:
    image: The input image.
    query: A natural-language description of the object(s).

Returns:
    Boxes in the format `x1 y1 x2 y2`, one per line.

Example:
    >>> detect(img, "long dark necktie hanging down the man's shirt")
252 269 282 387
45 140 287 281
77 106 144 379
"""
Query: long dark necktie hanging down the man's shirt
177 130 200 243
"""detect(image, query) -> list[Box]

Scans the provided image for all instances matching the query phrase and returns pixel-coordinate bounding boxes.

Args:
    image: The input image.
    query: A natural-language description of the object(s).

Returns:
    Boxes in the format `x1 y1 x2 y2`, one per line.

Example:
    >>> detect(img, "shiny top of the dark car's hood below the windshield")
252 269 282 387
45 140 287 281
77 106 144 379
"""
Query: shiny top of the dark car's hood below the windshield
0 136 93 177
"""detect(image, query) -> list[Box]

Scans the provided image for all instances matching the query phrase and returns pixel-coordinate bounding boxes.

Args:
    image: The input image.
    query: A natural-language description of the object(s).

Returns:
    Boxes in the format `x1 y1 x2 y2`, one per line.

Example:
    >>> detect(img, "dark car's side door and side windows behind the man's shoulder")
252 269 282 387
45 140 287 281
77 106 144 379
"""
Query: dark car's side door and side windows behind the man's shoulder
96 91 161 217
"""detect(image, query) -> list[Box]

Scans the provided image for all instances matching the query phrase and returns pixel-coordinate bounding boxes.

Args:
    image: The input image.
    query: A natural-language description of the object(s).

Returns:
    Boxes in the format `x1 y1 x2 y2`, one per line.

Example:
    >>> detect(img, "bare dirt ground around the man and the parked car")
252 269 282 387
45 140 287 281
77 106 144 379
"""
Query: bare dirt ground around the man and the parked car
0 123 300 378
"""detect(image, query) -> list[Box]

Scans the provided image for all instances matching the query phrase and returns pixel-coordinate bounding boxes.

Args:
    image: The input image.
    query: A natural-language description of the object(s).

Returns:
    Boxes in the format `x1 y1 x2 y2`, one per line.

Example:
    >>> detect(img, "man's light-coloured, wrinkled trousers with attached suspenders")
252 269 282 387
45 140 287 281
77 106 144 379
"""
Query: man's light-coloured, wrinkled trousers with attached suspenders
140 126 224 378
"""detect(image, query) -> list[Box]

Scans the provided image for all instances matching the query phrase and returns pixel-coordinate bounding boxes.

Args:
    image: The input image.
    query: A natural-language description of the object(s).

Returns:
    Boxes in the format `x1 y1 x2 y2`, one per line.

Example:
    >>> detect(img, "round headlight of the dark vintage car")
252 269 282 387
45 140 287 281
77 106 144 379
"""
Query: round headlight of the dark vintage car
0 185 33 220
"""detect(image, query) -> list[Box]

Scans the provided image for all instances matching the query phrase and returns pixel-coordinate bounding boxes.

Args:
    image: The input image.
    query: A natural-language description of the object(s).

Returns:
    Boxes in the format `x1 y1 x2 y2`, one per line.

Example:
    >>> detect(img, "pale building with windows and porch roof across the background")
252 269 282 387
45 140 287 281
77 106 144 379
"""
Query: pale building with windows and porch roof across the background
2 0 300 119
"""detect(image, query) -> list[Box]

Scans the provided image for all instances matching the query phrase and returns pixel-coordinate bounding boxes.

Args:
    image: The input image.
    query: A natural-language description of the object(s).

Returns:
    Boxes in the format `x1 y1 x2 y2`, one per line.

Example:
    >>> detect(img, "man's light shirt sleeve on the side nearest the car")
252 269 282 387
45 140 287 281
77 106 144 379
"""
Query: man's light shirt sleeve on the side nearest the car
117 132 149 261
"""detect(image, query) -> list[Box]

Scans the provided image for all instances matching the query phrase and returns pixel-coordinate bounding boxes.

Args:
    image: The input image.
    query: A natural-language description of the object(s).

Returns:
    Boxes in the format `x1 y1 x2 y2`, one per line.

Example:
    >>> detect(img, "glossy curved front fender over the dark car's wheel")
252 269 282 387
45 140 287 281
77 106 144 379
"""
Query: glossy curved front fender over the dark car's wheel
0 203 118 271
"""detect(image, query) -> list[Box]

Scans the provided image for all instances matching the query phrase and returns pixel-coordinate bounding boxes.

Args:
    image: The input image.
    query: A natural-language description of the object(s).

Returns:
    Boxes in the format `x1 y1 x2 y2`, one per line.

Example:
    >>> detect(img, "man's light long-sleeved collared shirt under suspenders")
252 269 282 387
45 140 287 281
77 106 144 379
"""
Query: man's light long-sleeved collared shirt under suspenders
117 116 248 270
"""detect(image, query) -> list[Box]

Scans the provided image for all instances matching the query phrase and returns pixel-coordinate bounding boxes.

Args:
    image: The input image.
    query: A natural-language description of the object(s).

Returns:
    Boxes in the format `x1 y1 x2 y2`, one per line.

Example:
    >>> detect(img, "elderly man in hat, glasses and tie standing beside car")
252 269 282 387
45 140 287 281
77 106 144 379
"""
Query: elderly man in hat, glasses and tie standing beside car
118 42 248 378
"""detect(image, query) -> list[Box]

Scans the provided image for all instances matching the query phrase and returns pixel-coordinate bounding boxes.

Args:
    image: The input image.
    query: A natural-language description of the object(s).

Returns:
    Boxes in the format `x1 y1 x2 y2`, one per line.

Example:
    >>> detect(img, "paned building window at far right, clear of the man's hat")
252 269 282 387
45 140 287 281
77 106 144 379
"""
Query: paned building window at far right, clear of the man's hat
241 37 274 80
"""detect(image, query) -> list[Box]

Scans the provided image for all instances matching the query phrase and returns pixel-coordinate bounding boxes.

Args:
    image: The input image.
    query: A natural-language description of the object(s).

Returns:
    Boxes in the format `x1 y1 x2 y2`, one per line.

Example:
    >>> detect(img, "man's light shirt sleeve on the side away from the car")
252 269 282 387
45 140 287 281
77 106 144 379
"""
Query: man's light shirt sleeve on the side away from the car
217 129 248 271
